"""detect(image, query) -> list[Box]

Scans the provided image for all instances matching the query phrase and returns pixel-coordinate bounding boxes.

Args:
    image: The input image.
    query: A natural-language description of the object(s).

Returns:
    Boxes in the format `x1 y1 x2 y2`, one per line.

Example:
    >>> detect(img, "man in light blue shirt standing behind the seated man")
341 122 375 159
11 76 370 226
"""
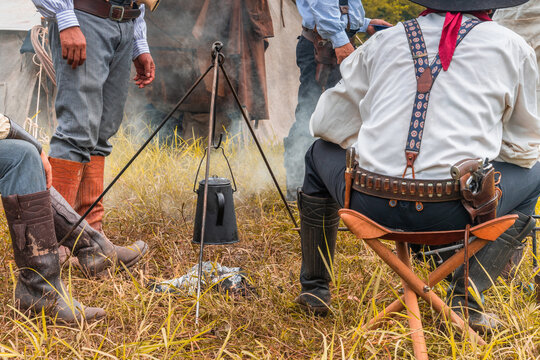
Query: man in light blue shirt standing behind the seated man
283 0 391 200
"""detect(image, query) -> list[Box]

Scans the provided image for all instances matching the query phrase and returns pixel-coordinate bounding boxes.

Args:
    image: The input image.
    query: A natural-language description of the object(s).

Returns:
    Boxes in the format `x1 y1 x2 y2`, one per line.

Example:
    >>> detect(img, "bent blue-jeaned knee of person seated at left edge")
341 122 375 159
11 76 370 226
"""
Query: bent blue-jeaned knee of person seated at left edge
0 139 47 196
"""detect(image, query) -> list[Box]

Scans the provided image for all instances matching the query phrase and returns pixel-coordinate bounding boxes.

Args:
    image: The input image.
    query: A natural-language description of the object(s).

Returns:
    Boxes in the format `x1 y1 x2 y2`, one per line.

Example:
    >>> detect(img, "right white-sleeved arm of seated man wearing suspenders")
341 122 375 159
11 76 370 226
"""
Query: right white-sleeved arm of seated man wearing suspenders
498 49 540 168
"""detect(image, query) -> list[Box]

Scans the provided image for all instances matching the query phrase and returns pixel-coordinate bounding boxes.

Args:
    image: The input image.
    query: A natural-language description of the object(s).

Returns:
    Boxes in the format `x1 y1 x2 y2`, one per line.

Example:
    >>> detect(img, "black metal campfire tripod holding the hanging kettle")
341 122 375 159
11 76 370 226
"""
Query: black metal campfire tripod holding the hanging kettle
59 41 298 324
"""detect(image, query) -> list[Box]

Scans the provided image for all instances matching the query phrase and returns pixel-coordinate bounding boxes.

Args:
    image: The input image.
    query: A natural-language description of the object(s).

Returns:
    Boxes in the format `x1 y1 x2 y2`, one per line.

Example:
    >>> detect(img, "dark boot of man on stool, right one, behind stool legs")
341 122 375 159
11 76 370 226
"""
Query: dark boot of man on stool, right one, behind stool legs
448 212 535 333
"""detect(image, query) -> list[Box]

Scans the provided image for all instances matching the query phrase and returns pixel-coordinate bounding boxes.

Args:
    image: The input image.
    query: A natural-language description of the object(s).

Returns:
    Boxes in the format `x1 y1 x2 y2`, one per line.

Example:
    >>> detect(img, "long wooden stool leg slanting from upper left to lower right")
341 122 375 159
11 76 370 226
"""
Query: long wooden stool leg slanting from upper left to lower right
364 239 486 345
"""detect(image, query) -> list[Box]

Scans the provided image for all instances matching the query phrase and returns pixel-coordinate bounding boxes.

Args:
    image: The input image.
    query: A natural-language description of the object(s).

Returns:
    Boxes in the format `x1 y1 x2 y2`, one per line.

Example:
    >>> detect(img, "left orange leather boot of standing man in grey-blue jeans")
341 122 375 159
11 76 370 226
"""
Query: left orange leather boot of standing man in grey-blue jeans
49 157 84 207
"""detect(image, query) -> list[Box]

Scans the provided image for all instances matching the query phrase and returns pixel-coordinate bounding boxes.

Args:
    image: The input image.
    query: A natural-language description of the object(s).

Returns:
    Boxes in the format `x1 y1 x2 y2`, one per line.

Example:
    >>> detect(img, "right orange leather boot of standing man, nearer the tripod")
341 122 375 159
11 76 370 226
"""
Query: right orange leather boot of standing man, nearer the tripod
75 155 105 233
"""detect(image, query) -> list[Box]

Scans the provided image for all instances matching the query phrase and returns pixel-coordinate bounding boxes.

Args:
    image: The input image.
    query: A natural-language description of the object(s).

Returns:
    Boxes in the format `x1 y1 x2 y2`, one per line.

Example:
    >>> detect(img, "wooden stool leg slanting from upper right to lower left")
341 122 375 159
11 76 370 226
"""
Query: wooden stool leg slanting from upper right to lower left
366 239 489 329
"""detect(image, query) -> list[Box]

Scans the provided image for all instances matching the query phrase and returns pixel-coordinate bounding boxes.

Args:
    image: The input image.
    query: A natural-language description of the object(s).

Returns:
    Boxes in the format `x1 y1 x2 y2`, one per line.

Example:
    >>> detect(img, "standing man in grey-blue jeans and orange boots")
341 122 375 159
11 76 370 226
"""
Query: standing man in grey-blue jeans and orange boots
33 0 155 245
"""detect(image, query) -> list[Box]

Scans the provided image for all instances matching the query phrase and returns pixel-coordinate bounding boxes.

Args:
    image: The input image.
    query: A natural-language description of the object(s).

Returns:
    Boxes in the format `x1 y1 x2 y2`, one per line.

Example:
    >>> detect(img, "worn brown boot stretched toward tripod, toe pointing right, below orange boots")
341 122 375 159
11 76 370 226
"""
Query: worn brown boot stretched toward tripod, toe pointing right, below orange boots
50 187 148 277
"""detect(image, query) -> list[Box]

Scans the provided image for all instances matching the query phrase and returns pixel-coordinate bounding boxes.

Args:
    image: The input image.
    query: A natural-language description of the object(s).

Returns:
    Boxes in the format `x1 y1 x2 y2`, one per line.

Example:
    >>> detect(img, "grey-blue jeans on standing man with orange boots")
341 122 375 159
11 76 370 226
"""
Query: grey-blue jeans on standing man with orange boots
49 10 133 162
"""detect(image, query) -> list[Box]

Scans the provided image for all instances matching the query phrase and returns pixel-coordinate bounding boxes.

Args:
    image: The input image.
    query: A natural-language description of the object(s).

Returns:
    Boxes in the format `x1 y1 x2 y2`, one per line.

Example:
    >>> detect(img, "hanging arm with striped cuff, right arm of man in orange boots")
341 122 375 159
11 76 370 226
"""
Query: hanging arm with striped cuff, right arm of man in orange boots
133 5 156 88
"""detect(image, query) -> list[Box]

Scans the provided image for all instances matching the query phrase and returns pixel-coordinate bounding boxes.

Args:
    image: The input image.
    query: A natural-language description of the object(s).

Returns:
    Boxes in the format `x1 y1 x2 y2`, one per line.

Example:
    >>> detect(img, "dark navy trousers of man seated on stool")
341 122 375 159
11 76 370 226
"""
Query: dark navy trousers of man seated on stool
302 140 540 231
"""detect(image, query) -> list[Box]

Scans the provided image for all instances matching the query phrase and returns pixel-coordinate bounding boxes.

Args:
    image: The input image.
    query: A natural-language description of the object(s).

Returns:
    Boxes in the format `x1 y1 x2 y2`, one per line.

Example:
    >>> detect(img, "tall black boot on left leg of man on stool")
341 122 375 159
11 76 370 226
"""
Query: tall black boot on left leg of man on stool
295 190 339 316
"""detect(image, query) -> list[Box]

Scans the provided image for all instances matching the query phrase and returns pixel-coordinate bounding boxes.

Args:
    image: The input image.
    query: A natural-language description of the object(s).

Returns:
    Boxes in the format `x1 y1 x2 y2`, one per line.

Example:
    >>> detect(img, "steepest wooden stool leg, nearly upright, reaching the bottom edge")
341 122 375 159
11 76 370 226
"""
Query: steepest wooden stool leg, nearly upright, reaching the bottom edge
396 243 428 360
